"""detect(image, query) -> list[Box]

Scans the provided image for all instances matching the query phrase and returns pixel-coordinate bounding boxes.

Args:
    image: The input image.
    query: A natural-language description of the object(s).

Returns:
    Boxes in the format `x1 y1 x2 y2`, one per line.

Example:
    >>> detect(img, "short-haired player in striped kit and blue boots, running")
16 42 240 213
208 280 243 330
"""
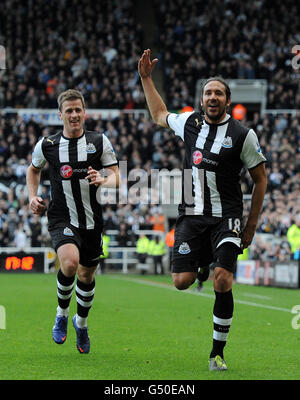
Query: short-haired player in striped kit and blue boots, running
26 89 120 353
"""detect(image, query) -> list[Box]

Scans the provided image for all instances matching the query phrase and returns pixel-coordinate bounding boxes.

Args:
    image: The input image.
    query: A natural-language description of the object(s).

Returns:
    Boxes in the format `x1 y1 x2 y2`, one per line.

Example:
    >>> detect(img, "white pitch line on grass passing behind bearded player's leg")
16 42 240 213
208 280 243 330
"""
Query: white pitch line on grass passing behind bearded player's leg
113 276 291 313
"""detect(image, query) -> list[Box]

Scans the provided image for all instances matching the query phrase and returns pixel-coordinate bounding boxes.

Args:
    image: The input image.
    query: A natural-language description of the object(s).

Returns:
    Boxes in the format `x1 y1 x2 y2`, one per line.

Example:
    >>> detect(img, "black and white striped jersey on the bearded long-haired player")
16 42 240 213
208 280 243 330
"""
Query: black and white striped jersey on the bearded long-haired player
167 112 266 217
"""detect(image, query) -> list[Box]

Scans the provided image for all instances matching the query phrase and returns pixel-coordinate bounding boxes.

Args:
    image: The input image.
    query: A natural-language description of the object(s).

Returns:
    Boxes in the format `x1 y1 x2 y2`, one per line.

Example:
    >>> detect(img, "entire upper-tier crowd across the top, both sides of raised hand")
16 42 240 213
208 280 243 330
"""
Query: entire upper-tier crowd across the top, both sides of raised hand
0 0 300 109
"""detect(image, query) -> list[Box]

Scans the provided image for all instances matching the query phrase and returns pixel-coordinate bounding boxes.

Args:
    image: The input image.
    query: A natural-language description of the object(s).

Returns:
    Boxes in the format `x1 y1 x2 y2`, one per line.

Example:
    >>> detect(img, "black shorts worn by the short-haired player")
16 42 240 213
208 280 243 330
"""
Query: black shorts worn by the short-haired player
49 224 103 267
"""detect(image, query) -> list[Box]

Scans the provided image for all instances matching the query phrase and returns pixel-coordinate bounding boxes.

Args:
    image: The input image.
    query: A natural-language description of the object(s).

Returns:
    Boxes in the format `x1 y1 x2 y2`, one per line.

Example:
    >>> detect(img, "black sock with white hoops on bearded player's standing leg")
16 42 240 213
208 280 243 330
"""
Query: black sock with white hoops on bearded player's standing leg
210 290 233 358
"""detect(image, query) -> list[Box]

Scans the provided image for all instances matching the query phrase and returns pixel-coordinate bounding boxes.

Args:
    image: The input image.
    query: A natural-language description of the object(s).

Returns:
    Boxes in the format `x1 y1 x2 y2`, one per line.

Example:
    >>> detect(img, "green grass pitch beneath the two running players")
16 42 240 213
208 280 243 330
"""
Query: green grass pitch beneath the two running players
0 273 300 380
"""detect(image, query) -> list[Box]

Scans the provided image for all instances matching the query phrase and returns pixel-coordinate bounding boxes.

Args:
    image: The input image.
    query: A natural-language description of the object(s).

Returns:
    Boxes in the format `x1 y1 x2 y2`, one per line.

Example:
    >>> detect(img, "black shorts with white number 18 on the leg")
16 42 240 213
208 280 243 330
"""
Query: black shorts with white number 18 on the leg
172 215 242 273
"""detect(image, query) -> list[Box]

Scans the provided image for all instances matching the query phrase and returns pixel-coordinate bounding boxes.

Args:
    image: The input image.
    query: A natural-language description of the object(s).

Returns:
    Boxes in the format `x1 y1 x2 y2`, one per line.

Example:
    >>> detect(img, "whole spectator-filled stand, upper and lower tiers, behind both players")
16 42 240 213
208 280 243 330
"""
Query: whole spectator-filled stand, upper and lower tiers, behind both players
0 0 300 268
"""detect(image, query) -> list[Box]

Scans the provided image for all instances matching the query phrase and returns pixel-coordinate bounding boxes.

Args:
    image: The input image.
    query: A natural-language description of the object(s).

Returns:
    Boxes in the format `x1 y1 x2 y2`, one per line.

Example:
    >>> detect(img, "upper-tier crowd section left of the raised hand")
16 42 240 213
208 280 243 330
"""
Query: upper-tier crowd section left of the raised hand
0 0 145 109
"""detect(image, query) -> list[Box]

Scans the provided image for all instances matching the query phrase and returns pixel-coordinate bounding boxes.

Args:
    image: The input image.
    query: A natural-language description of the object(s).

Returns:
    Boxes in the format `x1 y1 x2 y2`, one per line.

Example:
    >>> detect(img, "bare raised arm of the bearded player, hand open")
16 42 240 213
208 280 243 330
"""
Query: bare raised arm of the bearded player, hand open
138 49 169 128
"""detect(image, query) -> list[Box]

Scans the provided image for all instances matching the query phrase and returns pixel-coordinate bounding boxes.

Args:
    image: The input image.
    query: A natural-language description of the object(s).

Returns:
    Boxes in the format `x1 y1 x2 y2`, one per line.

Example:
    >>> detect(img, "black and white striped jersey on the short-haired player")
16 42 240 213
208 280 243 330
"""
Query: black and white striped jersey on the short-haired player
32 130 117 229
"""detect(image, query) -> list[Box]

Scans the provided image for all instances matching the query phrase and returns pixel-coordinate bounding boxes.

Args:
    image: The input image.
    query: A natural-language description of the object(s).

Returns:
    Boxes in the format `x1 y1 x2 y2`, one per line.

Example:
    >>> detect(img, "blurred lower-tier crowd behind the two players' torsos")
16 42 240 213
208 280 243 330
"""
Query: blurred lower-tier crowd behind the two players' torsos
0 109 300 256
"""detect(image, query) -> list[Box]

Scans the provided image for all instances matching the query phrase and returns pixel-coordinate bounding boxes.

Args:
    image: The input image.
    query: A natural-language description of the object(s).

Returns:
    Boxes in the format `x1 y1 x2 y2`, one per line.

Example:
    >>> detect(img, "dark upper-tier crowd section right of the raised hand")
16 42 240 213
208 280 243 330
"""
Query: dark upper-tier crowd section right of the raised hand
154 0 300 109
